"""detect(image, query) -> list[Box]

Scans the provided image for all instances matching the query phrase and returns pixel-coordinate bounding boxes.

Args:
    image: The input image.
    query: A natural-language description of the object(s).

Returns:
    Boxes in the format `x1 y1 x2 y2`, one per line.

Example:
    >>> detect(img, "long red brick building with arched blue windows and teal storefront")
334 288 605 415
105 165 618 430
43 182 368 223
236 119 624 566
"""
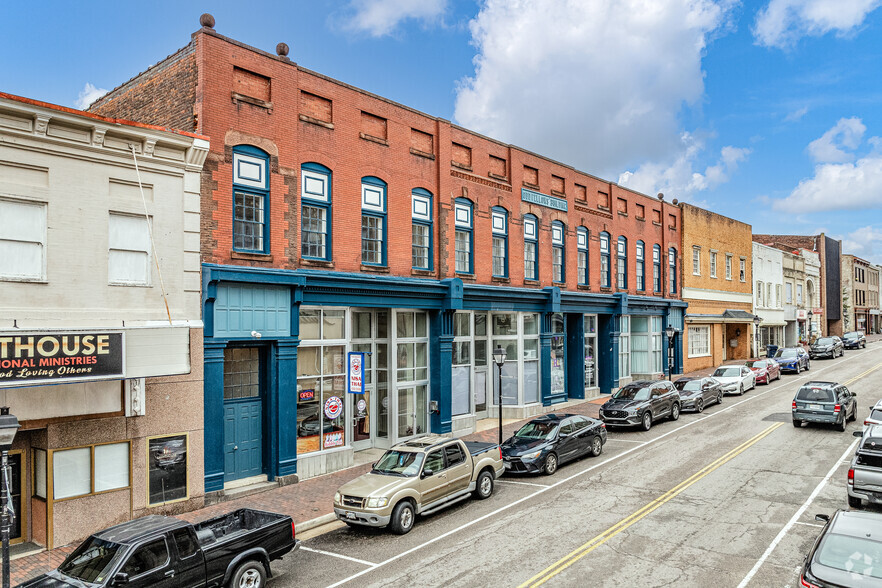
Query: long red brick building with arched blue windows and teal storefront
92 22 685 491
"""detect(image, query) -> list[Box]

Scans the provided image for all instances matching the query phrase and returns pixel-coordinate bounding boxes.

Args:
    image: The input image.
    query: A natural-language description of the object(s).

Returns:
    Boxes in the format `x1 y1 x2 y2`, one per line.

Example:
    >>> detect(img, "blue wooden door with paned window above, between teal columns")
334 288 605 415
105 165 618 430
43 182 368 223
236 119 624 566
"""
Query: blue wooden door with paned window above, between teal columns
224 348 265 482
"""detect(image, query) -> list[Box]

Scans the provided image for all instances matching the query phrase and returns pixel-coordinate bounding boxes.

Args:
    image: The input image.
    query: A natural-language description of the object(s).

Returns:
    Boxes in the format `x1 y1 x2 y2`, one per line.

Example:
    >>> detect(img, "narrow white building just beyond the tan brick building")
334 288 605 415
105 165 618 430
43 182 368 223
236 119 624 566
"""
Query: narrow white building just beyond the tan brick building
753 242 787 355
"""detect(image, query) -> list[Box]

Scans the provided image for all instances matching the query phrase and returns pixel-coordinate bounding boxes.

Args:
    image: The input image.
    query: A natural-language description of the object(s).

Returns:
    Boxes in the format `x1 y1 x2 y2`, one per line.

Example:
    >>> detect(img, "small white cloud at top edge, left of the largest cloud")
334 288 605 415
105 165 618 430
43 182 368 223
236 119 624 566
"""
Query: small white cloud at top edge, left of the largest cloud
336 0 448 37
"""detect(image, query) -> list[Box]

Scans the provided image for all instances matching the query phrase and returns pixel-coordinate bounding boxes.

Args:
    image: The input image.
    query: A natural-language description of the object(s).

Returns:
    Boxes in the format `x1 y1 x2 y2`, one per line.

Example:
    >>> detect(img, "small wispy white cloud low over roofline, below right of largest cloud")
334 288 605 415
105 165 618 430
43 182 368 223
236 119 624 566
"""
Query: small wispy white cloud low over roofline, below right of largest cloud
619 133 750 199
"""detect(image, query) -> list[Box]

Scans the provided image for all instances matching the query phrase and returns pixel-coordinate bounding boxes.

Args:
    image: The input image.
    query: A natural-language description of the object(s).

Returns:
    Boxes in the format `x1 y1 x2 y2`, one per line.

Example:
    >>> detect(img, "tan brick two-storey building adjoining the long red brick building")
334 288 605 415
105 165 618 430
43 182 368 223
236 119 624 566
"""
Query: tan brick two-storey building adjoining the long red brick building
680 204 754 372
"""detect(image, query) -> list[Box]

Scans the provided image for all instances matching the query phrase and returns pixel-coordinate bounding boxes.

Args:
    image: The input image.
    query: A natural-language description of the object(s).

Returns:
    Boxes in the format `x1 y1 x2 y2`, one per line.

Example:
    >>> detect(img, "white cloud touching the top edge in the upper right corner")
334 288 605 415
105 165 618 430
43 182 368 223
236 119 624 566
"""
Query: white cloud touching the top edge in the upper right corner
753 0 882 49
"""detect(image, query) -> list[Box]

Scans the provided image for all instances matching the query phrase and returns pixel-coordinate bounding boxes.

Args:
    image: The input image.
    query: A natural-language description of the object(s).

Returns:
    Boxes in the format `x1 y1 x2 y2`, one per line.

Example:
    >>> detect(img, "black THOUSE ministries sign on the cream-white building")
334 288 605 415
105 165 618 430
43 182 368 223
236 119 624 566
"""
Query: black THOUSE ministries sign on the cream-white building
0 332 125 387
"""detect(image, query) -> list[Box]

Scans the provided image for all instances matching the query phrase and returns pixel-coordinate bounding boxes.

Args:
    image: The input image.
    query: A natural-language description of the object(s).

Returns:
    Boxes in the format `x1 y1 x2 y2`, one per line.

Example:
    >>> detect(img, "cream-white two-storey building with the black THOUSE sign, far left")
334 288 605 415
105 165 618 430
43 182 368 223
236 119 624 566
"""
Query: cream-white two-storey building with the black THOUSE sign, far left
0 94 208 547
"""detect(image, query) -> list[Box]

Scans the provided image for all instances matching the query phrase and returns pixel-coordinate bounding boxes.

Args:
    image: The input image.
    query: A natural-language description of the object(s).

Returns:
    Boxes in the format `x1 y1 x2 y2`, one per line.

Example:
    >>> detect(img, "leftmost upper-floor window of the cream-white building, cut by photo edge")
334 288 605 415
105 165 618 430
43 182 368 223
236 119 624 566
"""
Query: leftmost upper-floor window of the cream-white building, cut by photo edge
0 200 46 281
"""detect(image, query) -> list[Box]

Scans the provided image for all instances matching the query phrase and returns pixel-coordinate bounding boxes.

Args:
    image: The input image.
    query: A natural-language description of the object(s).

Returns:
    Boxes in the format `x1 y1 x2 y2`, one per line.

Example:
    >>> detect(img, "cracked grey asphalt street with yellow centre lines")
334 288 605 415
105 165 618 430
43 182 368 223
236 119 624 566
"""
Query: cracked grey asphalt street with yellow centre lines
269 345 882 588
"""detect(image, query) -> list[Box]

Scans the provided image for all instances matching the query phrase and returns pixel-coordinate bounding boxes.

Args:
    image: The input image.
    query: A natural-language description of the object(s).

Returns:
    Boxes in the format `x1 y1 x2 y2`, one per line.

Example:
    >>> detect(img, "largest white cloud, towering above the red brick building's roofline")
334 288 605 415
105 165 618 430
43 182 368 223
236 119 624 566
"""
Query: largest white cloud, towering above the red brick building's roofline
455 0 734 184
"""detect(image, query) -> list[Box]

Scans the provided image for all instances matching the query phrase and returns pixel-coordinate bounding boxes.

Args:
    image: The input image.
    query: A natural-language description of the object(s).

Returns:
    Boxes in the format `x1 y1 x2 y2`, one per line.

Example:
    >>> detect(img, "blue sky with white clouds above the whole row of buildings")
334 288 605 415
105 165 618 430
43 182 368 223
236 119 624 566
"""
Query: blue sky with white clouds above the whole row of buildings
0 0 882 263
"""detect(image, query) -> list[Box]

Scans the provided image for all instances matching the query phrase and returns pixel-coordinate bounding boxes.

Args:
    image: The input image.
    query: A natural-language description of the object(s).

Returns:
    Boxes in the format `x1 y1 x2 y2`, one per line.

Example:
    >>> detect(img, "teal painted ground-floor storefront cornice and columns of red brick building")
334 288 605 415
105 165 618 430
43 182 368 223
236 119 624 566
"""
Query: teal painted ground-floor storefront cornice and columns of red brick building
203 264 685 492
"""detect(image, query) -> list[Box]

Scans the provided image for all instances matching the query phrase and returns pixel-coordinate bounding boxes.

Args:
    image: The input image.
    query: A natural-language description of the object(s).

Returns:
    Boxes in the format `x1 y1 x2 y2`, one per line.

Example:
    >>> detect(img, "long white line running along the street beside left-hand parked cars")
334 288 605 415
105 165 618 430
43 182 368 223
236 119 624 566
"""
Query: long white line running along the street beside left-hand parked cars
326 347 882 588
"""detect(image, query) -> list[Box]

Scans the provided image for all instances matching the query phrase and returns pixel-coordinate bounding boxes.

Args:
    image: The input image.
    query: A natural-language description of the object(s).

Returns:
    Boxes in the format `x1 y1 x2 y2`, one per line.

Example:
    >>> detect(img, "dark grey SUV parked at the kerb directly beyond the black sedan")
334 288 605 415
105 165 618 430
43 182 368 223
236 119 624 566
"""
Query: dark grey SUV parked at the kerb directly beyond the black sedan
600 380 680 431
